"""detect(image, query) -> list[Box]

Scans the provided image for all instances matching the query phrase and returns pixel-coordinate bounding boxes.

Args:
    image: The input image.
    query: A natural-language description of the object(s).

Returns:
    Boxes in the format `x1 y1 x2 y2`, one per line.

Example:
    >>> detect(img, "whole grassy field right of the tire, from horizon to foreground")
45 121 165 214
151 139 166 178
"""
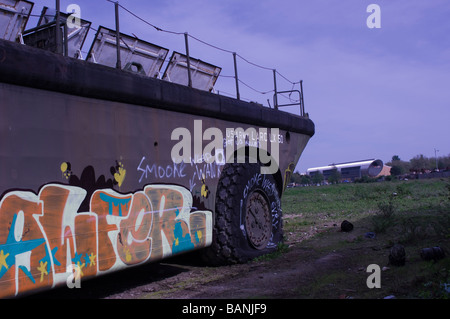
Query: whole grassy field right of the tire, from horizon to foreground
282 179 450 299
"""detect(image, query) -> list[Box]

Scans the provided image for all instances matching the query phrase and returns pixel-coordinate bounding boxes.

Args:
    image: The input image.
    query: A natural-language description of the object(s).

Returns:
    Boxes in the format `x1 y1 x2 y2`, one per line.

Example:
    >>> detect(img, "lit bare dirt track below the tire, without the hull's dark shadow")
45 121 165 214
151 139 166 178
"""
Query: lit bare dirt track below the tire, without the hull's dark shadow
106 248 343 299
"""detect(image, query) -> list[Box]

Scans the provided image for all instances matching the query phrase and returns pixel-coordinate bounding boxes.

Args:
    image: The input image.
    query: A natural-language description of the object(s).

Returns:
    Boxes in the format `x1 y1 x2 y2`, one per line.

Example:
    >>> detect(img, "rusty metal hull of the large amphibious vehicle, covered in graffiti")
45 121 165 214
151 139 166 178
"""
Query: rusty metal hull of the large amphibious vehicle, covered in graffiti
0 40 314 297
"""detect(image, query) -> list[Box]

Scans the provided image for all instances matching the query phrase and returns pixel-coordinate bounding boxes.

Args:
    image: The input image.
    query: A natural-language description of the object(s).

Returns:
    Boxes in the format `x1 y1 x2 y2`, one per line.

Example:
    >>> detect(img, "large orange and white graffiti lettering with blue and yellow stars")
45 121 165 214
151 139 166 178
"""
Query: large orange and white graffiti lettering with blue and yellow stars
0 184 212 297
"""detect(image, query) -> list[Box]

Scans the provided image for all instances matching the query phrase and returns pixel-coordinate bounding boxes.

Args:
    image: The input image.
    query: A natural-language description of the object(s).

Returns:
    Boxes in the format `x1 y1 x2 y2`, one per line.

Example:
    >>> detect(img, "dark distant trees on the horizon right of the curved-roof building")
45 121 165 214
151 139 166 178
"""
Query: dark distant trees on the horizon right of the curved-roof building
386 154 450 176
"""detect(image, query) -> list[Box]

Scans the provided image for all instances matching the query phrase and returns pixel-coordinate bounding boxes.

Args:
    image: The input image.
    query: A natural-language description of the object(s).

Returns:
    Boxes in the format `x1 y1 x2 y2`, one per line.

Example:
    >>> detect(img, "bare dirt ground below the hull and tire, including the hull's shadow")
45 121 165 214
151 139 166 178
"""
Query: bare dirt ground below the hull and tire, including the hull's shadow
30 224 360 299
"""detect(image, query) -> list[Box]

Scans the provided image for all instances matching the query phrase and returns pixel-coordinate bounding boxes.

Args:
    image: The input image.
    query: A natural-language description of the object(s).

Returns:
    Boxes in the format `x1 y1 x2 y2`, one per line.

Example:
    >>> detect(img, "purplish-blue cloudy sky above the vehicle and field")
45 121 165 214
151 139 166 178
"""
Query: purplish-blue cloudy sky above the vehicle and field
28 0 450 172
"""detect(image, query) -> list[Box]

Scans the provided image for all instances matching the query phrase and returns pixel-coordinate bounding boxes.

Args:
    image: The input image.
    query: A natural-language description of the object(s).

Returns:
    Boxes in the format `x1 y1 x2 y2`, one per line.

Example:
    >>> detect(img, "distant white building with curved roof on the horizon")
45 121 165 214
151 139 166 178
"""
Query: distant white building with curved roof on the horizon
306 159 390 180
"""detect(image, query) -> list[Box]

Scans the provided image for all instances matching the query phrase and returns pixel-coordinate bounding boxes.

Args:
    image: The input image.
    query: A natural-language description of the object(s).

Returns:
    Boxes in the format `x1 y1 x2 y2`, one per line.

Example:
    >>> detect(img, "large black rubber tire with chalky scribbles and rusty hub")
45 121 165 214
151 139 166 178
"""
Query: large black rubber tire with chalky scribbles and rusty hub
204 163 283 265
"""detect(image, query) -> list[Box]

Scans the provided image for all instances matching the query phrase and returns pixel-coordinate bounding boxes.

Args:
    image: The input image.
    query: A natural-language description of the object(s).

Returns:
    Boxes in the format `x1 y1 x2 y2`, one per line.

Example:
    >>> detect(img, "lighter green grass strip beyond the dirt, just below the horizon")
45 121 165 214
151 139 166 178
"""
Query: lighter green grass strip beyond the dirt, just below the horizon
282 180 450 230
